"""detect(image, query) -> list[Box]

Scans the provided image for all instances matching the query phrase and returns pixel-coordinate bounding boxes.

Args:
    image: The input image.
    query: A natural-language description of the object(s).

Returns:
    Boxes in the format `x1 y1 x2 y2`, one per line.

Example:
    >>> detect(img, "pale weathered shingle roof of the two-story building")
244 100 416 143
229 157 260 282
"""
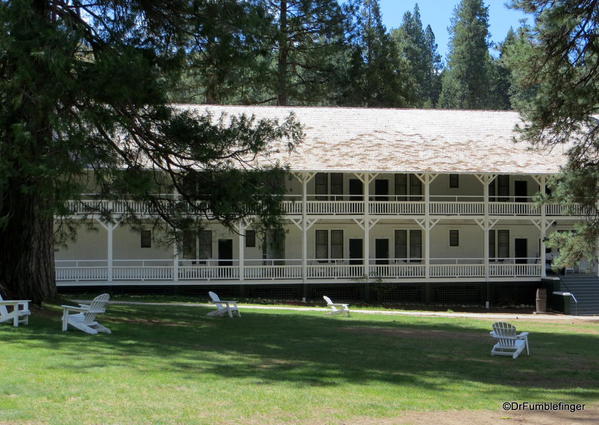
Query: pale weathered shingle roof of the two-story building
180 105 566 174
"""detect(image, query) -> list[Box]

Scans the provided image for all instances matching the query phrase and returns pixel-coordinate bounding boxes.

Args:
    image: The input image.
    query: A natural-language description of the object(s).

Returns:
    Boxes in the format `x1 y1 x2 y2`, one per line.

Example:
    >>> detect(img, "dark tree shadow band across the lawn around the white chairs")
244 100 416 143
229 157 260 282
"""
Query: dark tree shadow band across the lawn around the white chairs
0 306 599 400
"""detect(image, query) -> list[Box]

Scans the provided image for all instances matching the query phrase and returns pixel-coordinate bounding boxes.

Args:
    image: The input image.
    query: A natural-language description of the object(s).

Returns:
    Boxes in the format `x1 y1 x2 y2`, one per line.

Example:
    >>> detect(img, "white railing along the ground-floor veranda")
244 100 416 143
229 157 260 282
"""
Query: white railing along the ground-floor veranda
56 258 542 282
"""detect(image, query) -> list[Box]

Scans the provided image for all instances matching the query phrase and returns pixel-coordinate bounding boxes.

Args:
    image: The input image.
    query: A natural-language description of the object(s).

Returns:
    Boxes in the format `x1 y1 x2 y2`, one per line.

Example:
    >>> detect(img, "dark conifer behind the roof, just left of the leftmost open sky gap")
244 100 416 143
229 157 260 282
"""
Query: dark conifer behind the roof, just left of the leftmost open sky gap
340 0 408 107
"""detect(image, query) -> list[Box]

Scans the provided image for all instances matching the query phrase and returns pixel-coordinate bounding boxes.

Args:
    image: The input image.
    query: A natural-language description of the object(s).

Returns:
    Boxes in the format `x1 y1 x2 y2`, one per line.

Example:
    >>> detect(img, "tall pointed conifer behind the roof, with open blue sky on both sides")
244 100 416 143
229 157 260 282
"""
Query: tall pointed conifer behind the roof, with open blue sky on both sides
439 0 491 109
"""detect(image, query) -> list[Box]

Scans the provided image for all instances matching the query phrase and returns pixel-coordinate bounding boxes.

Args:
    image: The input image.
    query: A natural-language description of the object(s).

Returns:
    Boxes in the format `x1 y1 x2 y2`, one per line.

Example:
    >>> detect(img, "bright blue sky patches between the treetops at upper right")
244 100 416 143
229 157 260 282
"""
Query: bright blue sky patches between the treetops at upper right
380 0 526 59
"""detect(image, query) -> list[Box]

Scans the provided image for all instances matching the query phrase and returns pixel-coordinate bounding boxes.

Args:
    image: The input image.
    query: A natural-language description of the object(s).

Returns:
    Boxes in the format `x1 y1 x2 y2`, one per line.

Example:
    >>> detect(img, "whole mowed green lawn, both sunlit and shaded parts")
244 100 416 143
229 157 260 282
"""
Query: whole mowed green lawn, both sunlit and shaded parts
0 305 599 425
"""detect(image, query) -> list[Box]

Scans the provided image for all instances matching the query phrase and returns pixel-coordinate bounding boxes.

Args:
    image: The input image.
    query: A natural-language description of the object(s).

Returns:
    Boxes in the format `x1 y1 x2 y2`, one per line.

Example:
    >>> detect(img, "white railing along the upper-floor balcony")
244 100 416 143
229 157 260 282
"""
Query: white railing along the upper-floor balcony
67 195 585 216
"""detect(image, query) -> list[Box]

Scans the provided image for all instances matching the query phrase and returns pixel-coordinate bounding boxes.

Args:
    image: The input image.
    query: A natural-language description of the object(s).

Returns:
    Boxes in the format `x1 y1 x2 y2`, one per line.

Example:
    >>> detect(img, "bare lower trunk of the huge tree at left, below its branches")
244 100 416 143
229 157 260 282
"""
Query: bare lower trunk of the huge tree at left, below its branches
0 184 56 305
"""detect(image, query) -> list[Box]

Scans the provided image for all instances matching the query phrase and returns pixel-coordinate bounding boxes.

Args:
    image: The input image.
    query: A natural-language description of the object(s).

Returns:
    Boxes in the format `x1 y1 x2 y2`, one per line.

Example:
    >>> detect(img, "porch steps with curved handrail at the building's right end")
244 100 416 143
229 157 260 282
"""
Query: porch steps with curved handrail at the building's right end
560 274 599 316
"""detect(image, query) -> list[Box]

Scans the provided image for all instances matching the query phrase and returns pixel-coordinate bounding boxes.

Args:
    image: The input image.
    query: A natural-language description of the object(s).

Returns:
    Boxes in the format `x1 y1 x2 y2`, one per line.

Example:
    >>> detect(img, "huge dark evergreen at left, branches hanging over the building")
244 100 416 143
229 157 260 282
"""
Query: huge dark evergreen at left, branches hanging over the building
0 0 301 303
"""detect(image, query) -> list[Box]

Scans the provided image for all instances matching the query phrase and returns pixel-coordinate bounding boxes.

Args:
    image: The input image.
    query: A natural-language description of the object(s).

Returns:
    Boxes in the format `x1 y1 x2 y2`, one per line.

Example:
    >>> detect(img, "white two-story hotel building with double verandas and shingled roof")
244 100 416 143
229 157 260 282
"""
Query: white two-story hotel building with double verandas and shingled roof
56 106 593 301
